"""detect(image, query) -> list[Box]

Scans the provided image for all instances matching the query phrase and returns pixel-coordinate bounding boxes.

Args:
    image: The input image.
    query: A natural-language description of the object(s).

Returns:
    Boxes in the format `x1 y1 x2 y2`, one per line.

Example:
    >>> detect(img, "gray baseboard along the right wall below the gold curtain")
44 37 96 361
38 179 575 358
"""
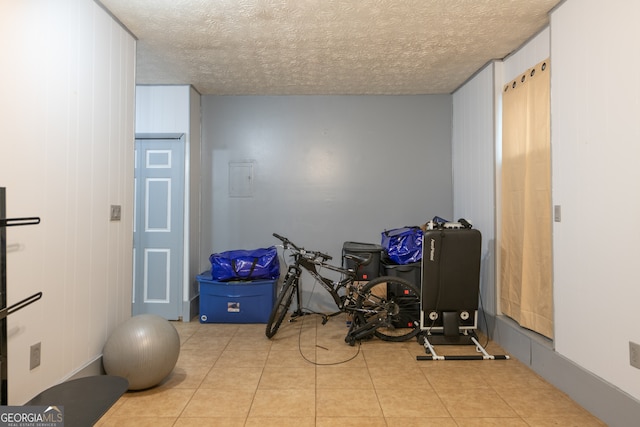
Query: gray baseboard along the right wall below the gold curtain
480 314 640 426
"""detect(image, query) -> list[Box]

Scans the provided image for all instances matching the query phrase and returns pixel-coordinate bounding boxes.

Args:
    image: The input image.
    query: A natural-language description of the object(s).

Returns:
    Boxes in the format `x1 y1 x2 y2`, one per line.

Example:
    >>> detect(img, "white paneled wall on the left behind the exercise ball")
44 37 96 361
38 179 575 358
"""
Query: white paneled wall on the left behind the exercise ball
0 0 135 404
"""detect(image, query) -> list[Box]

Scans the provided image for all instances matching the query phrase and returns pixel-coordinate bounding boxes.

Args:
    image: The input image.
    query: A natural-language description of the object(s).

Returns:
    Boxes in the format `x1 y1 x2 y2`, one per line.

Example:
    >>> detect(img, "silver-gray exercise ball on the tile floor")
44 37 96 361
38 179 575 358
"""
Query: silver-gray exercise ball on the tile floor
102 314 180 390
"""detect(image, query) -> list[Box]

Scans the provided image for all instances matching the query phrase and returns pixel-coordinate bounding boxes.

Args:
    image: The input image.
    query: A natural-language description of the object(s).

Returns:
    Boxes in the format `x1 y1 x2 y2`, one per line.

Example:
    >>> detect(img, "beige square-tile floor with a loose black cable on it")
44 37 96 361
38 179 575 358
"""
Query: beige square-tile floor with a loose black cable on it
97 316 605 427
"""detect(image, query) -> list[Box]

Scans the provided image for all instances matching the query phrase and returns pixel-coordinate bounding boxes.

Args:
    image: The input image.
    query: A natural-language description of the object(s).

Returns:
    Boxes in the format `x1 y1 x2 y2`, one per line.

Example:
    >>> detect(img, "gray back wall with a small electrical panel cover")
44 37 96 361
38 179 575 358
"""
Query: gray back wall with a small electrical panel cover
202 95 453 310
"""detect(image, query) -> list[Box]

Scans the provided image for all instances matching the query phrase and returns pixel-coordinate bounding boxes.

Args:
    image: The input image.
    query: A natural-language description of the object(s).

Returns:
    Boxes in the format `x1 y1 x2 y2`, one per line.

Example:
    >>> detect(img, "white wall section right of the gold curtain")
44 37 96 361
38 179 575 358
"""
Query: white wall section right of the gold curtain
551 0 640 399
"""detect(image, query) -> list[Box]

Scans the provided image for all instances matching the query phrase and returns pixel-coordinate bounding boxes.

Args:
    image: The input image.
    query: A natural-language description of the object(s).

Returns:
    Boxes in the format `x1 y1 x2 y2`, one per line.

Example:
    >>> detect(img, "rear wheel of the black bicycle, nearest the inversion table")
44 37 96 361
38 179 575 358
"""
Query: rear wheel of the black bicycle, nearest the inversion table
355 276 420 342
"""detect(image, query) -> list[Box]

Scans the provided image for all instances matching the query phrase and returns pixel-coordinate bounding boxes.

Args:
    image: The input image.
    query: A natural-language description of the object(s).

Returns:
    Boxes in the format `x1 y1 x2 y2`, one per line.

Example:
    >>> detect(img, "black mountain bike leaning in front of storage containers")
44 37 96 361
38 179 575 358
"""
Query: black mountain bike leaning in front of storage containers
266 233 420 345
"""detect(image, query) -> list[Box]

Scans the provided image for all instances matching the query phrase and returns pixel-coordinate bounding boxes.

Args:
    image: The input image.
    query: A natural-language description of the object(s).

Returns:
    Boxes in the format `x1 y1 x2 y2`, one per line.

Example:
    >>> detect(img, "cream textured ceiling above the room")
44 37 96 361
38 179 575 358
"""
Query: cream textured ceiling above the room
99 0 560 95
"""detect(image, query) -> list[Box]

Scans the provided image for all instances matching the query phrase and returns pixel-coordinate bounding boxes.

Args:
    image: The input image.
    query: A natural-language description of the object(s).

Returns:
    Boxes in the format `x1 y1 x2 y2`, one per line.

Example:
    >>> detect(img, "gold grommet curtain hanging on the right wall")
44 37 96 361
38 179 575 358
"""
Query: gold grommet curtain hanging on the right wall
500 60 553 338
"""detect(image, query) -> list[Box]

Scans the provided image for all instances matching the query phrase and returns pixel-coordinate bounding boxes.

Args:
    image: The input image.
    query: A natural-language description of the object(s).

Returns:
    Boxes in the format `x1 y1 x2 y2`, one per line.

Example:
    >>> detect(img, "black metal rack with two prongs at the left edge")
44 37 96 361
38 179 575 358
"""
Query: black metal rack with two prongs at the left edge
0 187 42 406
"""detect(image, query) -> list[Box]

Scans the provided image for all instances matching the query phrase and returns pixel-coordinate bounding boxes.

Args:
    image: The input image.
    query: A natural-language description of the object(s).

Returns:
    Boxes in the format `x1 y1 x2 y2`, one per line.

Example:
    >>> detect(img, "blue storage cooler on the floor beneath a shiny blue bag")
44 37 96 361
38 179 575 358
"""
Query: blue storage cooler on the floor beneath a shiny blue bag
196 271 277 323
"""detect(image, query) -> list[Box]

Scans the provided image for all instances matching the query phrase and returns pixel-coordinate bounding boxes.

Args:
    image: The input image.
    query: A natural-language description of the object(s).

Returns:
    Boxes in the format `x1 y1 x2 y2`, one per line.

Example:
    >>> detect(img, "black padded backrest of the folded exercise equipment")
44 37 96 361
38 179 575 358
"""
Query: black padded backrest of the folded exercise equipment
420 228 482 336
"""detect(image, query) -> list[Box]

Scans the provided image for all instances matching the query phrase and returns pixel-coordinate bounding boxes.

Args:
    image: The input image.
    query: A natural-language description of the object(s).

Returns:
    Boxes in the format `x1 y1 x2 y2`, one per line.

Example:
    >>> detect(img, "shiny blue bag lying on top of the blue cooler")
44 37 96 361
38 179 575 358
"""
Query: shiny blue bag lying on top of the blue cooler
209 246 280 282
